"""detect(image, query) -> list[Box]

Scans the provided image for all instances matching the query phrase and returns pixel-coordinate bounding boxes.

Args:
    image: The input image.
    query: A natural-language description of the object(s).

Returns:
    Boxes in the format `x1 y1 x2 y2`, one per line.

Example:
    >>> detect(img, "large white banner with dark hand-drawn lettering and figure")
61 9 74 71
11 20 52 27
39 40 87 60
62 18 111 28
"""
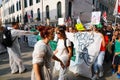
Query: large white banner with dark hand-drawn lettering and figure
69 32 102 78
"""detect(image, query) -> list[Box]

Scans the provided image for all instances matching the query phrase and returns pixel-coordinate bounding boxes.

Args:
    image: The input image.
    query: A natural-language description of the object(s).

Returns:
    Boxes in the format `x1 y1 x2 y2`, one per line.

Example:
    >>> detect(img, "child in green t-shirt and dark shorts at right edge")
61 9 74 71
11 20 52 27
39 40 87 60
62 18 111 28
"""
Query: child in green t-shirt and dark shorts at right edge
112 34 120 79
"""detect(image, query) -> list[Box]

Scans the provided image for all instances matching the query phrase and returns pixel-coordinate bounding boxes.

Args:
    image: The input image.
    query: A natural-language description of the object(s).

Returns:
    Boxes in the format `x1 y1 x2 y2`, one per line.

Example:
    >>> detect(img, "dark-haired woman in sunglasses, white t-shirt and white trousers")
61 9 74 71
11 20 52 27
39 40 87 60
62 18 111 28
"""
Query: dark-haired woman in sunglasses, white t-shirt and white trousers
54 27 72 80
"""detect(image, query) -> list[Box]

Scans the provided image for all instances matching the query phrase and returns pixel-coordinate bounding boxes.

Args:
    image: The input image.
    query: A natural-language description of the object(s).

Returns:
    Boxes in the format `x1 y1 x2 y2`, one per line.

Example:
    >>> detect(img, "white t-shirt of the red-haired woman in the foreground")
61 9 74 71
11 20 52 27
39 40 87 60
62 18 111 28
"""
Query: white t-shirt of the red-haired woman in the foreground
32 40 53 67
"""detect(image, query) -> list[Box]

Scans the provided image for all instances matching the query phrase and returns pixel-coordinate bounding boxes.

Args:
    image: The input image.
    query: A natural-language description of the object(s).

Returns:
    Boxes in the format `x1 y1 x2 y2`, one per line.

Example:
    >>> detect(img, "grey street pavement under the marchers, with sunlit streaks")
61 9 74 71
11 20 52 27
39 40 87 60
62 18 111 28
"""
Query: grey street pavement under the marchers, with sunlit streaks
0 43 118 80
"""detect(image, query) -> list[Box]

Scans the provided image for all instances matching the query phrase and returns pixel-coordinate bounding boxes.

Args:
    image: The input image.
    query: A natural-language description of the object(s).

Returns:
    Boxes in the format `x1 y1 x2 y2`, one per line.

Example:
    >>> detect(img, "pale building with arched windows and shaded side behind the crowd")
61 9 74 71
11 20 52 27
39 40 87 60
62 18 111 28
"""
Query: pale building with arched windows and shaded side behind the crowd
1 0 93 24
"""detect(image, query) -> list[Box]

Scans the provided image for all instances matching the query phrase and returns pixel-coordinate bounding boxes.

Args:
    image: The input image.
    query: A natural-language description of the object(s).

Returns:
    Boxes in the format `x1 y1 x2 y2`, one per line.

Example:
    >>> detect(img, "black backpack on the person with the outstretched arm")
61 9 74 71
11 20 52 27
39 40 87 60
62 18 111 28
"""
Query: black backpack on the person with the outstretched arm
1 28 16 47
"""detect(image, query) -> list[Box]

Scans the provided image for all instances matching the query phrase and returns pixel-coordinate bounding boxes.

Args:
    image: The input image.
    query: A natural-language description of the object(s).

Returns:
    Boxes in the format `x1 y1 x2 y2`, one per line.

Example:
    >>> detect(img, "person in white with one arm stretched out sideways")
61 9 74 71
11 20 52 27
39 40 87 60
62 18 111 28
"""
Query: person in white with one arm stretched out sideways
7 22 37 74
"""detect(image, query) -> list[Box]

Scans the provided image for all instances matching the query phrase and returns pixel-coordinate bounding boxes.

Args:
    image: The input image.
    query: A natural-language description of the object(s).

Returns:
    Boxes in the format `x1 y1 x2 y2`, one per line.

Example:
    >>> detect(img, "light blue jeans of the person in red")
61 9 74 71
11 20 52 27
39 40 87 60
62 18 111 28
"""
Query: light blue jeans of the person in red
93 51 105 73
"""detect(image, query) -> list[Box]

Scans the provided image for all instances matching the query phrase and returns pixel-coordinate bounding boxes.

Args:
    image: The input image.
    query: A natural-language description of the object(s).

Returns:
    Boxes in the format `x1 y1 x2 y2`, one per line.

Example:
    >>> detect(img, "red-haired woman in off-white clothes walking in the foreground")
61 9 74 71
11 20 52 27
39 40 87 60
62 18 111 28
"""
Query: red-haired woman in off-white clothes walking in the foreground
31 26 64 80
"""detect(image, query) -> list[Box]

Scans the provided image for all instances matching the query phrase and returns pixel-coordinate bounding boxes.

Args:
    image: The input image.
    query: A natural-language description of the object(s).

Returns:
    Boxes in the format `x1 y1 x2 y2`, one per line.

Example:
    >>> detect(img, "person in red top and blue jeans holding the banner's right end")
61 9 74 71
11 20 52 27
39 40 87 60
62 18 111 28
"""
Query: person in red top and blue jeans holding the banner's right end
92 25 105 80
